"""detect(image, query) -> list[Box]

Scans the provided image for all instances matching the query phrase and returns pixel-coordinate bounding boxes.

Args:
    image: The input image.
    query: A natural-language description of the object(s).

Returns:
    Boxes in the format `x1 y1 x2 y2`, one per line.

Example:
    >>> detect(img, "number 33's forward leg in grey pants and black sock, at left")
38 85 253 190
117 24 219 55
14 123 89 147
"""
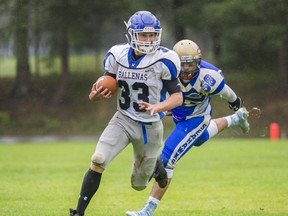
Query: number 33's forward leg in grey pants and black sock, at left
70 113 129 216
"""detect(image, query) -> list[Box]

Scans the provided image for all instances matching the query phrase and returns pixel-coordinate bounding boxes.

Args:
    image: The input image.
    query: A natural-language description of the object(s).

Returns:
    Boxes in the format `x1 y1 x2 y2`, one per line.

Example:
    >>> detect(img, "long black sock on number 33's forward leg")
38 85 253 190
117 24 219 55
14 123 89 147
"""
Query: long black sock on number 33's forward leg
77 169 102 215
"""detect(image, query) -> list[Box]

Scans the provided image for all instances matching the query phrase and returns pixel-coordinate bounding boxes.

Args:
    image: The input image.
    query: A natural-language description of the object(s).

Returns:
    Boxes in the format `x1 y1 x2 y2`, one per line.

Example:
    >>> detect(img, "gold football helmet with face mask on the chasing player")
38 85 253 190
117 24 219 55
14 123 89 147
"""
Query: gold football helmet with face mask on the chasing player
173 40 202 81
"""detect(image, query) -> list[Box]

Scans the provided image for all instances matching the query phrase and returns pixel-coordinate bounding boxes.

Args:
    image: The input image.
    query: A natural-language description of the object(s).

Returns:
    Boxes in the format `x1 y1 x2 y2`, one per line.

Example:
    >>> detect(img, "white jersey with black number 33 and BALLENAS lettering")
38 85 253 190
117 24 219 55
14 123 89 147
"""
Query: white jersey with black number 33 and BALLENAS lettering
104 44 181 122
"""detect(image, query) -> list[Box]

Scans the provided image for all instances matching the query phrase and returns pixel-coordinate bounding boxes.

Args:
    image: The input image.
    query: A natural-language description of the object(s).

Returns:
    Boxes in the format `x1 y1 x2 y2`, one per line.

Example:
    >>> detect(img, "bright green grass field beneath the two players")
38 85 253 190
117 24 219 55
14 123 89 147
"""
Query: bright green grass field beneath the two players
0 139 288 216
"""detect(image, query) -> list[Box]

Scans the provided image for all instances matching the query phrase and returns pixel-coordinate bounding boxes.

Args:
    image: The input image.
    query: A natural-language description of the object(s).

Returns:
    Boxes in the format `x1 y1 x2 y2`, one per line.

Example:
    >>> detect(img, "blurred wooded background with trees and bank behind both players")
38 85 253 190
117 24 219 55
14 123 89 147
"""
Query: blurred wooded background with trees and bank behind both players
0 0 288 136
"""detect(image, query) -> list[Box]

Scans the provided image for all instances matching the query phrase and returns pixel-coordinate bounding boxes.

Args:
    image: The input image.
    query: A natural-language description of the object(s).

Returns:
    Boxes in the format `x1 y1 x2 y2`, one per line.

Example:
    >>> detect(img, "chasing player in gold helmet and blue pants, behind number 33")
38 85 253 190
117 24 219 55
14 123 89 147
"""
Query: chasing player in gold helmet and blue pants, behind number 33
126 40 249 216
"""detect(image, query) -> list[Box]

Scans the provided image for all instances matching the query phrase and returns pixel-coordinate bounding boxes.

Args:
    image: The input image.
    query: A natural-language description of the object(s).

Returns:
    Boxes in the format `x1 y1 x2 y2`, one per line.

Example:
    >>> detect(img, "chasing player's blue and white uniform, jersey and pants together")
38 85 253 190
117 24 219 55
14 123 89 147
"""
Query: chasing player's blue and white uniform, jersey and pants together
161 60 226 170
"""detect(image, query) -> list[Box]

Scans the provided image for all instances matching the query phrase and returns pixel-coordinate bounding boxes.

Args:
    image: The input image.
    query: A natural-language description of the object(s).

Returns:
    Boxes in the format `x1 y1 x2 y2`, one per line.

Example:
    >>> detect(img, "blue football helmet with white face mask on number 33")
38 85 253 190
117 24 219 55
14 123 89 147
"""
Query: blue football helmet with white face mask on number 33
124 11 162 54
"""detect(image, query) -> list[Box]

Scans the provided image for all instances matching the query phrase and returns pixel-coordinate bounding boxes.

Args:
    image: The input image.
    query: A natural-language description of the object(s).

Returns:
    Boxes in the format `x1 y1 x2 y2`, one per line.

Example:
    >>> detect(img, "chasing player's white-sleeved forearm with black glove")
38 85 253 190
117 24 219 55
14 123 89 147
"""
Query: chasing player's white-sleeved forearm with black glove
219 84 243 111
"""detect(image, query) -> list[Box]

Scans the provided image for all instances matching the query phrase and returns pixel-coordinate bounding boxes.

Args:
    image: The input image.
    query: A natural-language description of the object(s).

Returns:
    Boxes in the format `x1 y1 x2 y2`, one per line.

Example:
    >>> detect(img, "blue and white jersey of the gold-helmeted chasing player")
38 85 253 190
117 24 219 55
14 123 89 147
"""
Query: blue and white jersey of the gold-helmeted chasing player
172 60 225 121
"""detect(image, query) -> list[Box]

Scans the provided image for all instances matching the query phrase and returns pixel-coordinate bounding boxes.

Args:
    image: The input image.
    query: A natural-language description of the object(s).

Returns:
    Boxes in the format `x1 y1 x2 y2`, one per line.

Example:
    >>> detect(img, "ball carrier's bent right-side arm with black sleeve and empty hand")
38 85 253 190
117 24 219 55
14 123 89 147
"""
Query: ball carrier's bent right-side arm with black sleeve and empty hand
138 78 183 115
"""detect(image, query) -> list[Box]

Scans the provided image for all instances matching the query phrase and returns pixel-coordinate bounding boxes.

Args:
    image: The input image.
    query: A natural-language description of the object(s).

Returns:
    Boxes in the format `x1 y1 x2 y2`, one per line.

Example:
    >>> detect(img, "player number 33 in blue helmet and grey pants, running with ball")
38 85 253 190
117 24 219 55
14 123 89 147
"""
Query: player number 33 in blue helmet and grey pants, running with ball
70 11 183 216
